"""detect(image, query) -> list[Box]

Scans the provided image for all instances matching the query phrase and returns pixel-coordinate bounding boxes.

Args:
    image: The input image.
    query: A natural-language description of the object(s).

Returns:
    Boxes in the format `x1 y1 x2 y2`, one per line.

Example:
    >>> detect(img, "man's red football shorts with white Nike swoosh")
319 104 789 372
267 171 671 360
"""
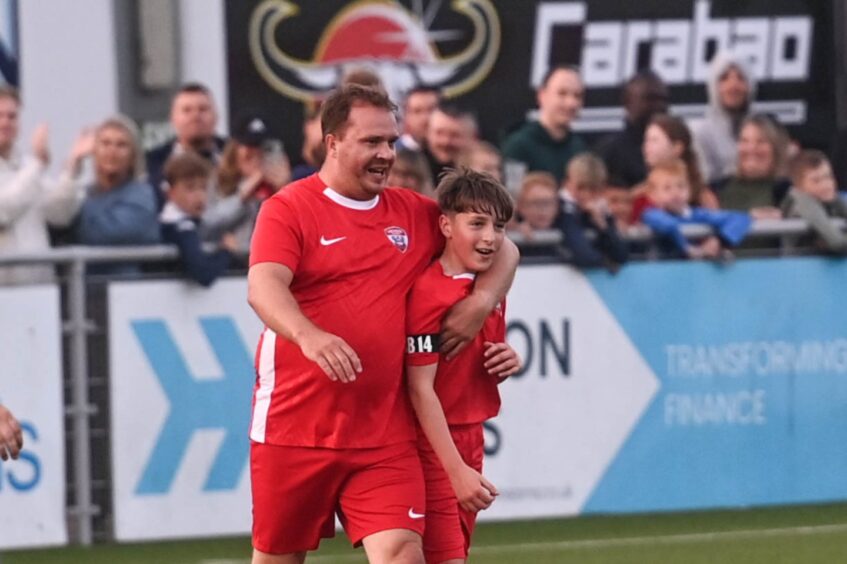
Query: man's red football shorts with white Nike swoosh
250 442 425 554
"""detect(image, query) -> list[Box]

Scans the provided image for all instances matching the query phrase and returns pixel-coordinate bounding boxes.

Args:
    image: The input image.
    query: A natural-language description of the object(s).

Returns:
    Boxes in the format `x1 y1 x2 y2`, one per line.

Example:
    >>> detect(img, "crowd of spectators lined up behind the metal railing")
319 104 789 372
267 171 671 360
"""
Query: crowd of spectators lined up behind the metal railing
0 48 847 285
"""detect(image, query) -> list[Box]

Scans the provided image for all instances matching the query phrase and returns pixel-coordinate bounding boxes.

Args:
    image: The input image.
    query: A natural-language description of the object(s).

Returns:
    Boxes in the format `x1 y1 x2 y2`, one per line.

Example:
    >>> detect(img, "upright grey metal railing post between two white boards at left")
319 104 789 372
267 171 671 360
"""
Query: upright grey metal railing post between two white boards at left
67 258 95 546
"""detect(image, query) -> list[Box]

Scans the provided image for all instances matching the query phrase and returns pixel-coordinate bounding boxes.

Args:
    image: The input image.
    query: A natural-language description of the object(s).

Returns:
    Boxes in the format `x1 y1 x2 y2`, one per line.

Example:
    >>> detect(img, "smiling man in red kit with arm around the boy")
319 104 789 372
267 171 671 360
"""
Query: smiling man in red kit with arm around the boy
248 85 518 564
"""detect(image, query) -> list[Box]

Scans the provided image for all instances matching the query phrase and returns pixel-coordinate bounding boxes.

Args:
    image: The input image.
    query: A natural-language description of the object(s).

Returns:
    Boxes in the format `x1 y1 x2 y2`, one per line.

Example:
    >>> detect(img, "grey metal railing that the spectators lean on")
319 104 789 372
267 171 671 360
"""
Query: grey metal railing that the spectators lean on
0 219 845 545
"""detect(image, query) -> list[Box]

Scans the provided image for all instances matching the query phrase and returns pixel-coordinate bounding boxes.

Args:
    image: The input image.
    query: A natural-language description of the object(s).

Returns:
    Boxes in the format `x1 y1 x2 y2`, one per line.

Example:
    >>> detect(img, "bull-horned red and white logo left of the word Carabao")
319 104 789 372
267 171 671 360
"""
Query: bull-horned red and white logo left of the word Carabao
249 0 500 102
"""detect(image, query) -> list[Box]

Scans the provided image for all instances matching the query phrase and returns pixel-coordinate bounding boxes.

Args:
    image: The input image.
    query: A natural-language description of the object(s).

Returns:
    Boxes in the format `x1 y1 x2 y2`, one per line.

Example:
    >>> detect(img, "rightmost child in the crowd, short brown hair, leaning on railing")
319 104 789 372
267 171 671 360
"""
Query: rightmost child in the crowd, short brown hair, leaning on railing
782 150 847 255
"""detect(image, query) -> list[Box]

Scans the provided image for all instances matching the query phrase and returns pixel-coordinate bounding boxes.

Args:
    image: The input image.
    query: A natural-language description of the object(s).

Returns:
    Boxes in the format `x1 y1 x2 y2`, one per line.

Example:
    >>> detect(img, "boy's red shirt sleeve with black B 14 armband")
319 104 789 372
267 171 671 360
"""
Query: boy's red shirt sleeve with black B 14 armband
406 270 447 366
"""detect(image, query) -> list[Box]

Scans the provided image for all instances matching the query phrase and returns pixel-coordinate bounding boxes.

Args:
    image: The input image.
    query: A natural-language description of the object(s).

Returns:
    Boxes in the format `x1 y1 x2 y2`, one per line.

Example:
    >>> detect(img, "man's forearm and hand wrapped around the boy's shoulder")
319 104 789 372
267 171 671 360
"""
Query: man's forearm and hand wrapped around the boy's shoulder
441 239 521 359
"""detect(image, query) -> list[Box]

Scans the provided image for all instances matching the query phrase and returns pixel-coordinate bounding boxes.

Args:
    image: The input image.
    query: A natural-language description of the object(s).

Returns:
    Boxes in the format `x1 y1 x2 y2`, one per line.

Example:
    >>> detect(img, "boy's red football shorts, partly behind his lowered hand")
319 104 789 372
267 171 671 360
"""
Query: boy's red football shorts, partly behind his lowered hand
418 423 484 562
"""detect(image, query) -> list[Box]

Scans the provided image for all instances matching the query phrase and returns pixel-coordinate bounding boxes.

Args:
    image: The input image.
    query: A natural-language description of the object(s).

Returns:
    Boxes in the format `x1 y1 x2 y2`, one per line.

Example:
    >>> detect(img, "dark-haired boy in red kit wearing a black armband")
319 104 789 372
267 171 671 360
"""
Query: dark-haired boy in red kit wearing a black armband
406 170 520 564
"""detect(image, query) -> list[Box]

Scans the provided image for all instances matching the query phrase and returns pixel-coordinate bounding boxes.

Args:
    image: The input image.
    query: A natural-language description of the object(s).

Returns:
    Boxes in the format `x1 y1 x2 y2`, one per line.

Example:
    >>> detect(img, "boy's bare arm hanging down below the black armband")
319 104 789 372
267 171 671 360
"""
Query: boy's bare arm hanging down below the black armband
406 364 497 512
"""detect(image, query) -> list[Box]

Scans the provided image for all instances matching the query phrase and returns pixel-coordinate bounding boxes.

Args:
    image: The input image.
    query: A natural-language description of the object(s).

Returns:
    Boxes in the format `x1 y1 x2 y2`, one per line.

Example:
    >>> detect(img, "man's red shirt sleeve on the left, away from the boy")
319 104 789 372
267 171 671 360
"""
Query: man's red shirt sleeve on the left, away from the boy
250 197 303 272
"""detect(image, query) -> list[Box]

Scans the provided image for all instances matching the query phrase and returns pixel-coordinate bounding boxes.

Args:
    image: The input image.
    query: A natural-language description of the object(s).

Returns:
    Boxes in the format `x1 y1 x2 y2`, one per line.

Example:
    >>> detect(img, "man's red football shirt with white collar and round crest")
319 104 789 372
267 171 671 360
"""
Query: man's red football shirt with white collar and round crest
250 174 443 448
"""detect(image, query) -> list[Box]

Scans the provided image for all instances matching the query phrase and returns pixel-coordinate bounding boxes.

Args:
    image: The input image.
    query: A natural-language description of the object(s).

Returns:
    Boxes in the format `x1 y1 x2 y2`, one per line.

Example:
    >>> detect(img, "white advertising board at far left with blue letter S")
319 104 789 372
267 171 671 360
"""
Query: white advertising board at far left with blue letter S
0 286 68 549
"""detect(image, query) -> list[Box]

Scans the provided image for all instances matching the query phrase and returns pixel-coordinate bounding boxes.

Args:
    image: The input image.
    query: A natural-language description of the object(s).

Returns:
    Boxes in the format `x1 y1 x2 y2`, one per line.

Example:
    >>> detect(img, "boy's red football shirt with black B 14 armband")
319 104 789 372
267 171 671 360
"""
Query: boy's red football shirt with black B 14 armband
406 261 506 425
